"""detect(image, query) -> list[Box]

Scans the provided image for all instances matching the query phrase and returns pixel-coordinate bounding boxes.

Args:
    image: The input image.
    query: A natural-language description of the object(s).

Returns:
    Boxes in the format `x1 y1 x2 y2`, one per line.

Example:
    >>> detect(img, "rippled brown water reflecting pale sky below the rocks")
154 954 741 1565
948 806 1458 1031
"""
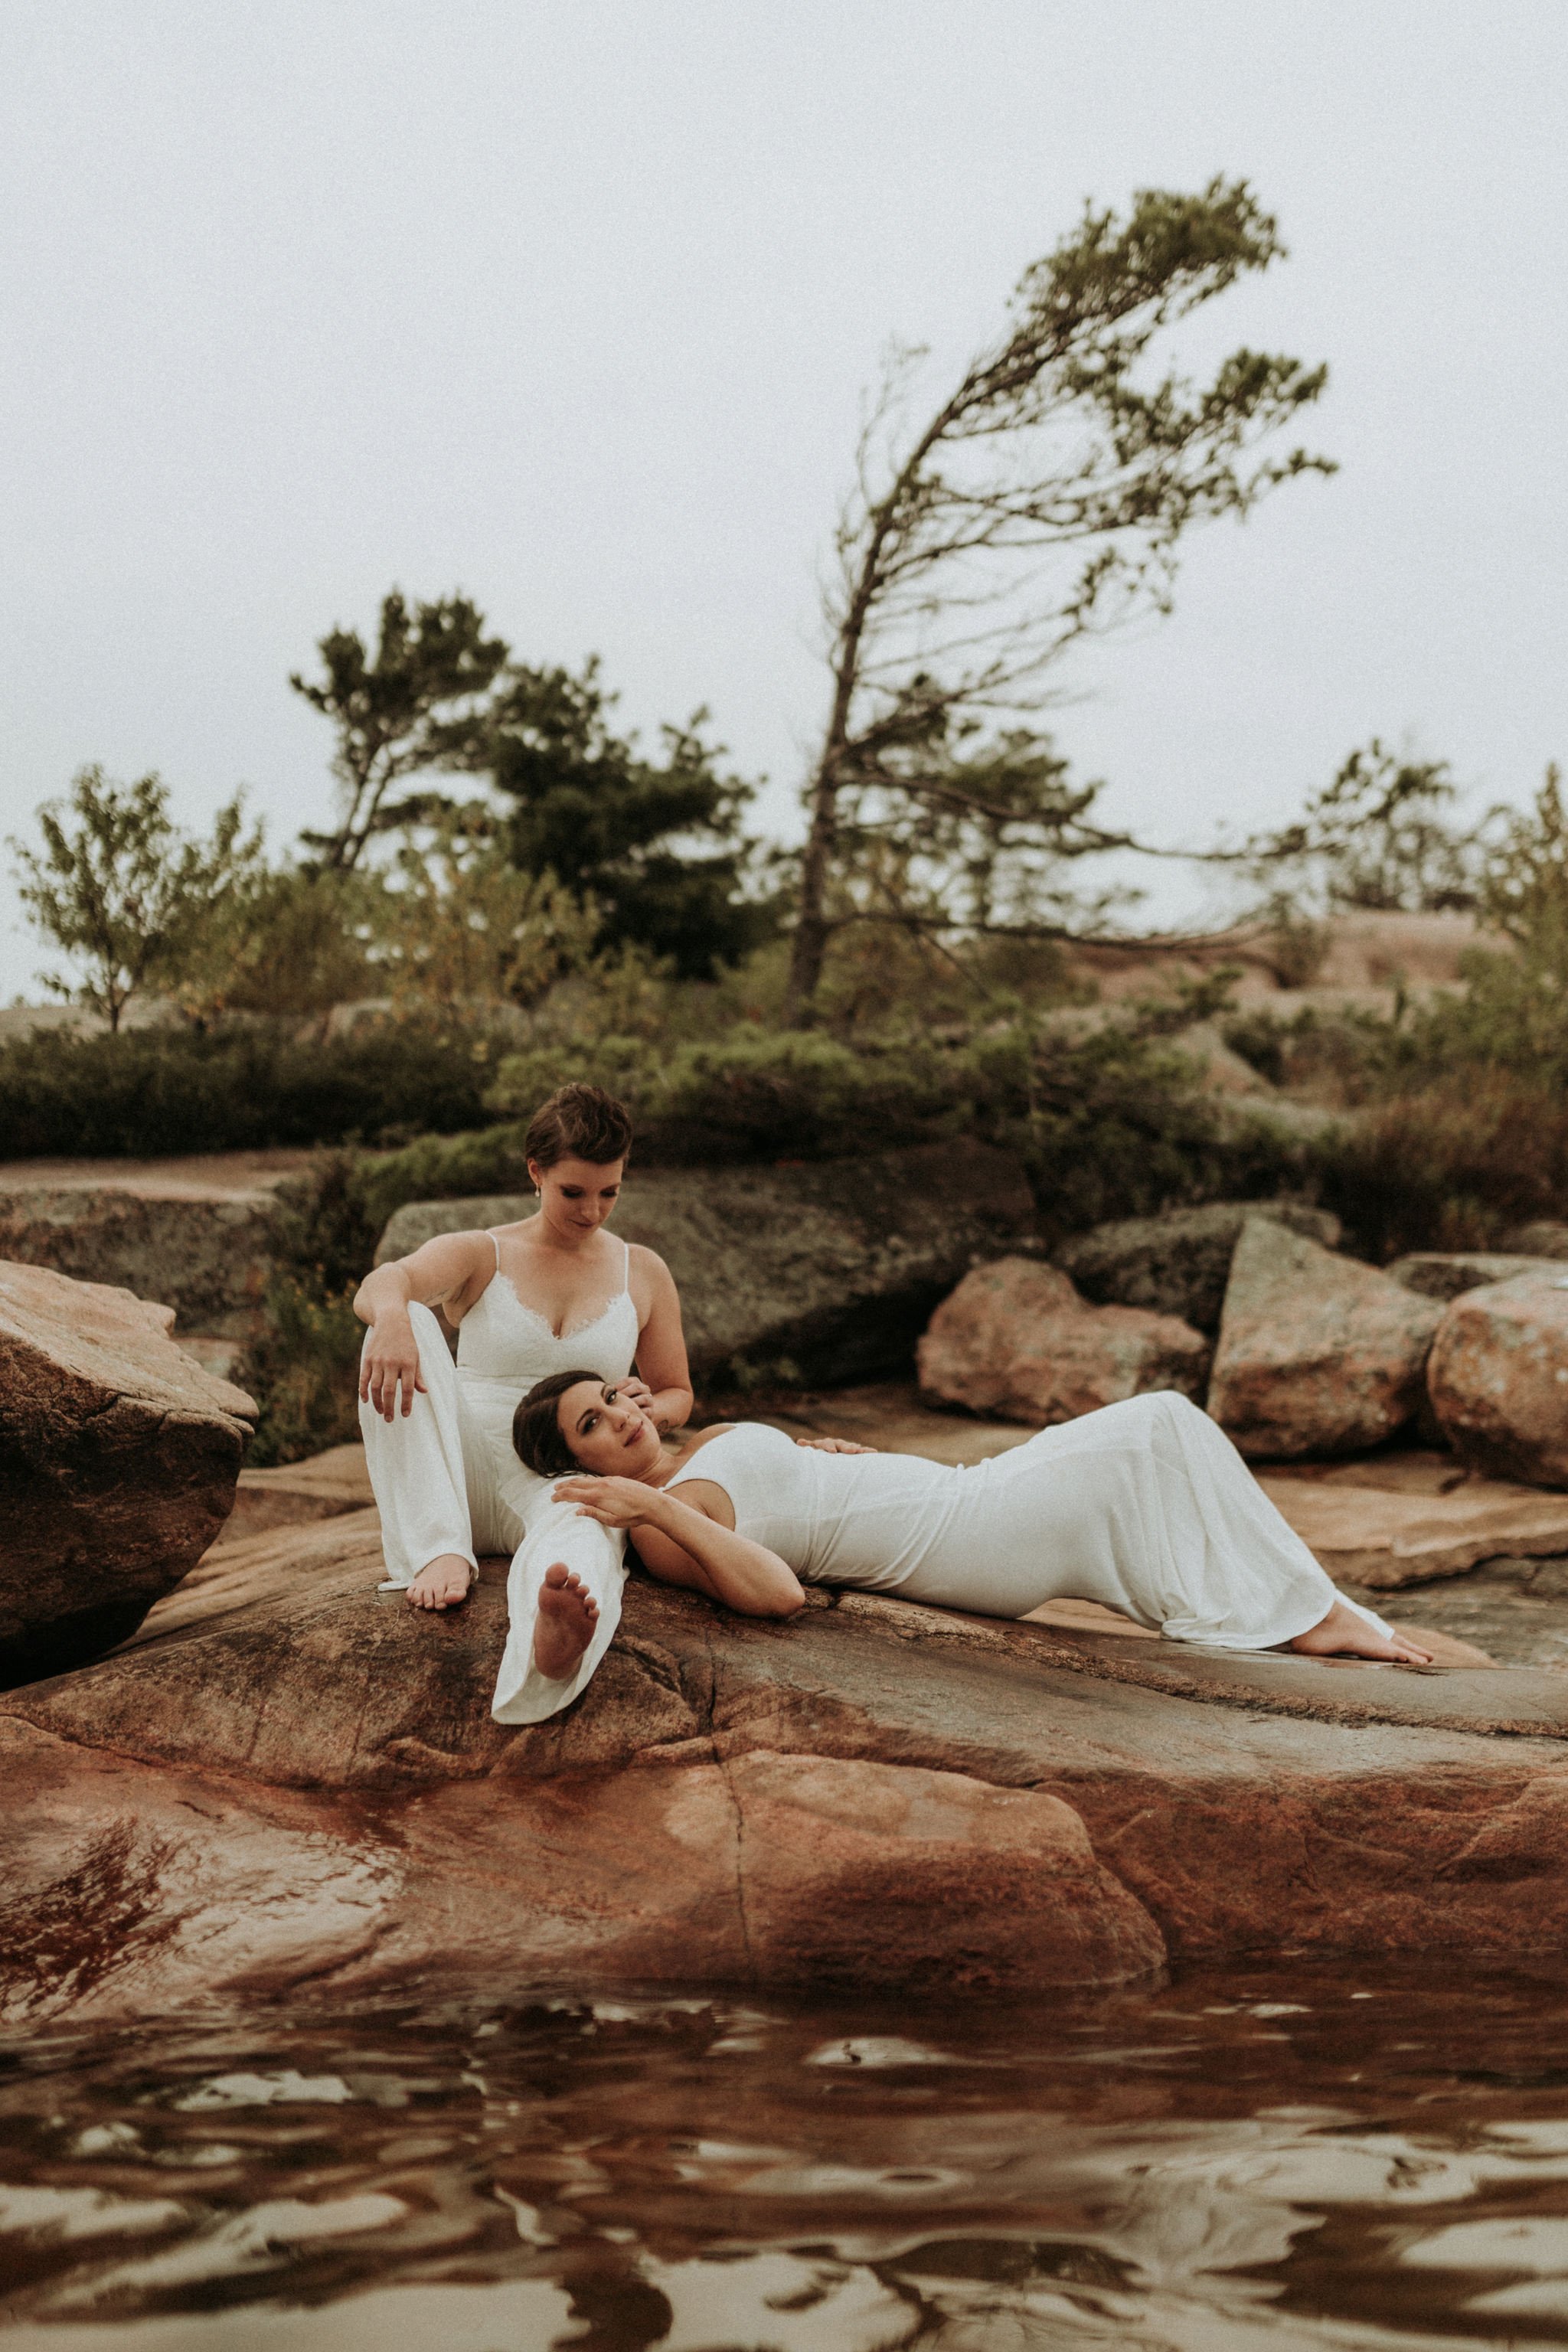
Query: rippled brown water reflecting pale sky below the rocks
0 1966 1568 2352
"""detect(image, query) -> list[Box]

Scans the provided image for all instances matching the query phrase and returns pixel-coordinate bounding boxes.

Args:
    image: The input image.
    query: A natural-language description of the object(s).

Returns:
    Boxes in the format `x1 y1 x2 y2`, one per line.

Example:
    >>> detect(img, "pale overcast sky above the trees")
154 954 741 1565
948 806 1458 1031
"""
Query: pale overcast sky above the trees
0 0 1568 998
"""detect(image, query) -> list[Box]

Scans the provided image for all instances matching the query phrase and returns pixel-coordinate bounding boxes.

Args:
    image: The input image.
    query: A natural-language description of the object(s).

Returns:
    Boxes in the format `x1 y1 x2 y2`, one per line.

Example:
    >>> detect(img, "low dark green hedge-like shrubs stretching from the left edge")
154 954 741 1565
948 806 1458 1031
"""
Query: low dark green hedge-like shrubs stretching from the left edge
0 1021 512 1159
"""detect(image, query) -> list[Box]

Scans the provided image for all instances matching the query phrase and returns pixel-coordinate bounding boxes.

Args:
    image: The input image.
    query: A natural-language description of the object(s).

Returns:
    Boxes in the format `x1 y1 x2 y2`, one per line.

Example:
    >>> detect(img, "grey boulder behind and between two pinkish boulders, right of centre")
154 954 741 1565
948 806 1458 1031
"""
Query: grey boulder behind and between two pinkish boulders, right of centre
1056 1200 1340 1336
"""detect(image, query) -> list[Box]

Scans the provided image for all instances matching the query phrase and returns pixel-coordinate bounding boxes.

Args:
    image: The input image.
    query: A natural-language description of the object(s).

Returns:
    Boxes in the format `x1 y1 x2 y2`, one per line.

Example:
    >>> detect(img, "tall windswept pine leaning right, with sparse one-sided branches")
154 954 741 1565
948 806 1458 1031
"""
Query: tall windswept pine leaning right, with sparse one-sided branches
790 178 1333 1018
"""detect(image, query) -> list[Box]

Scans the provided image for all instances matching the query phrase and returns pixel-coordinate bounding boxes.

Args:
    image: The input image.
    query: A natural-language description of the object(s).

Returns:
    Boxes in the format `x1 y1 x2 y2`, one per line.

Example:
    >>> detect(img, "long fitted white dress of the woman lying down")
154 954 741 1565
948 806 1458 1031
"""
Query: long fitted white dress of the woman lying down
670 1390 1387 1648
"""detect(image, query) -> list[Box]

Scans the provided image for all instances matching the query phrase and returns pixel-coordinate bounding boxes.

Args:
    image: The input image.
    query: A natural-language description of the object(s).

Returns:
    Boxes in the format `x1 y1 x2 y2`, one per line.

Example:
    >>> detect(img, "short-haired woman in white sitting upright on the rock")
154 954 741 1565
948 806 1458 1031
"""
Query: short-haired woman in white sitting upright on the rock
355 1086 691 1710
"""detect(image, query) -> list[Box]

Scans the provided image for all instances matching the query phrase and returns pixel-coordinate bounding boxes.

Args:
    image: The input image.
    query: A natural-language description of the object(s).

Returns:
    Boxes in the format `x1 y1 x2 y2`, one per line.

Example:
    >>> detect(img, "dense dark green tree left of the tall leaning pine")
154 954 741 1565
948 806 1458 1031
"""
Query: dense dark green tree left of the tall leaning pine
475 661 773 978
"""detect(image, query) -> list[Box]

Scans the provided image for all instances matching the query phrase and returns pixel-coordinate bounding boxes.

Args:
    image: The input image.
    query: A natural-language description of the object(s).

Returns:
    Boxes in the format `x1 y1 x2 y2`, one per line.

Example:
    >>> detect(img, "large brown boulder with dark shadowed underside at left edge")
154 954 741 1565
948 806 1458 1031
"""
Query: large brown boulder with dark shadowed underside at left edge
0 1263 256 1681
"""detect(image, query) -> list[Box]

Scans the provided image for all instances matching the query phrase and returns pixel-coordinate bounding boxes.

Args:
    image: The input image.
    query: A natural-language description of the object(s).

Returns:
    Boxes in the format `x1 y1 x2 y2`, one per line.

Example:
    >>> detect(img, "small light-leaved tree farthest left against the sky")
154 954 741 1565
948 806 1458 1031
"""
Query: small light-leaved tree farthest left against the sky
9 766 261 1031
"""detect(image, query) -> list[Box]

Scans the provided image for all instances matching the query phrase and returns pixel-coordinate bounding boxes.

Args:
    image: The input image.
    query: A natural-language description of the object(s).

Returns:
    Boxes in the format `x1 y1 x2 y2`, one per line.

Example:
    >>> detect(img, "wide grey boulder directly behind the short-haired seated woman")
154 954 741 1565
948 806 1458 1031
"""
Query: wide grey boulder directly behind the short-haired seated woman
376 1138 1034 1383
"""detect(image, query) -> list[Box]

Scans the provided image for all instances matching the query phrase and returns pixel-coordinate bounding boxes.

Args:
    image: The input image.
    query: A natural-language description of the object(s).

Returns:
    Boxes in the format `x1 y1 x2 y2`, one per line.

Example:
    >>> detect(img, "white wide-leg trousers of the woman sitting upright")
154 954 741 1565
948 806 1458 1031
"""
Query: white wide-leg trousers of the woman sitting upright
360 1305 626 1724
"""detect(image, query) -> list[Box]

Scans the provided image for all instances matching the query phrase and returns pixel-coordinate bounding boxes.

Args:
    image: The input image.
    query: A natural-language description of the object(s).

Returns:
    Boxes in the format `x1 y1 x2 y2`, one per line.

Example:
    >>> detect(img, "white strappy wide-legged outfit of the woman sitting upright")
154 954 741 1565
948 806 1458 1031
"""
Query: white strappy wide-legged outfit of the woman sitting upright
360 1233 637 1724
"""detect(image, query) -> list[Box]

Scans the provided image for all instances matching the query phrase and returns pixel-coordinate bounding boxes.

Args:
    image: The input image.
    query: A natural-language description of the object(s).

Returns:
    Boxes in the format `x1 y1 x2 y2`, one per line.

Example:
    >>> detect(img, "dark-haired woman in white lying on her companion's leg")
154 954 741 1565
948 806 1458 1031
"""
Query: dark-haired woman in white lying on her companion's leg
514 1371 1429 1665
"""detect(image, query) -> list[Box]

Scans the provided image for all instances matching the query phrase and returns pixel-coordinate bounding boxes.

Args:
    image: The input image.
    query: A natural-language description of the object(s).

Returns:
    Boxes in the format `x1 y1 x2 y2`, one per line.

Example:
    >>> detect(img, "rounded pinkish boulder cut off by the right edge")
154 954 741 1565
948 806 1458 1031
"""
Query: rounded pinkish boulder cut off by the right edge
1427 1266 1568 1487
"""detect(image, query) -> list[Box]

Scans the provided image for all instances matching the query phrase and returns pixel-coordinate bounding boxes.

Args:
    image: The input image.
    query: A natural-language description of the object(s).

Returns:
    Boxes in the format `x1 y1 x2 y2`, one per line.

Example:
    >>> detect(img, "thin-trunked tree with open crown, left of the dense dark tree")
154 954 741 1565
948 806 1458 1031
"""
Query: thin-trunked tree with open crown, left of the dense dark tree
289 588 508 873
